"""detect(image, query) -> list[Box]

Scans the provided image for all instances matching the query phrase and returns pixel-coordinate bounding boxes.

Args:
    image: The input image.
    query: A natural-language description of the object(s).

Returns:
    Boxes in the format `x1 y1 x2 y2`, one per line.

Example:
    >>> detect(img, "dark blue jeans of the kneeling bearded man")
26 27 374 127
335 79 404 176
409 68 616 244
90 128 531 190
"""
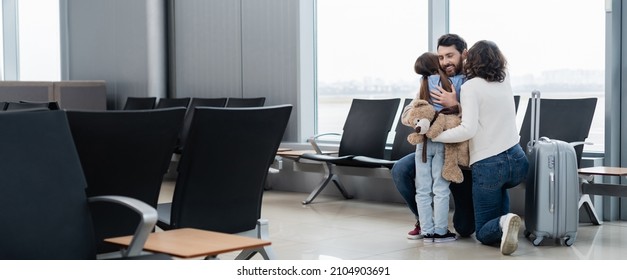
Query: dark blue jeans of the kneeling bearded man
392 153 475 237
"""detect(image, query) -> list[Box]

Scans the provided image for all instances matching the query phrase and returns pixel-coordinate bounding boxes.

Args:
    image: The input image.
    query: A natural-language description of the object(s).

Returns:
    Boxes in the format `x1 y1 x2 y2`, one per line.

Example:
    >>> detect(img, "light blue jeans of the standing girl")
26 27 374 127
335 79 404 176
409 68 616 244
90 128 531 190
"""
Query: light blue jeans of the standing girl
416 139 451 235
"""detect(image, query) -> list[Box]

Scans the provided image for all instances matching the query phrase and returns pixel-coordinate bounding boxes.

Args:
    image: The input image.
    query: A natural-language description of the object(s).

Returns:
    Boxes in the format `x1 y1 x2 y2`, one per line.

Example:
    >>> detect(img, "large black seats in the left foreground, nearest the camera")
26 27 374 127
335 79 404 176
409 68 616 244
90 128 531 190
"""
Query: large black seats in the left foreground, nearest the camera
0 105 292 259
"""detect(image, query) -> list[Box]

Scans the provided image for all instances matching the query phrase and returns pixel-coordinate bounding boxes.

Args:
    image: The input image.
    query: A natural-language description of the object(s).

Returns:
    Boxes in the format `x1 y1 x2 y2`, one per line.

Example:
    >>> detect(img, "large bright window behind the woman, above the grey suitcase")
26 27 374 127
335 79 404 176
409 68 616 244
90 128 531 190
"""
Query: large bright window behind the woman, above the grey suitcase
449 0 605 151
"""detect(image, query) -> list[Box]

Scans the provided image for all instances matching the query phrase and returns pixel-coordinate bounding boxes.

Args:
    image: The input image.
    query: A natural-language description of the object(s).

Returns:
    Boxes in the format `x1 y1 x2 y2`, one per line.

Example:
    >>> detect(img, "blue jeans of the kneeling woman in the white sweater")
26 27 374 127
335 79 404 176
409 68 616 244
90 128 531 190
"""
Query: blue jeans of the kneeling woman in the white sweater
471 144 529 245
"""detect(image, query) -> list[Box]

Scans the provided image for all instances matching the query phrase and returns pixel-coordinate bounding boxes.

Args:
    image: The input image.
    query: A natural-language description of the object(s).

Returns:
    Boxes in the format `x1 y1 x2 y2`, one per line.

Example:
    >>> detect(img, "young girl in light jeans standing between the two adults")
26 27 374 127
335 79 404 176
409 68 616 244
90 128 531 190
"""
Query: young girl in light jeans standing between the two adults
402 52 463 242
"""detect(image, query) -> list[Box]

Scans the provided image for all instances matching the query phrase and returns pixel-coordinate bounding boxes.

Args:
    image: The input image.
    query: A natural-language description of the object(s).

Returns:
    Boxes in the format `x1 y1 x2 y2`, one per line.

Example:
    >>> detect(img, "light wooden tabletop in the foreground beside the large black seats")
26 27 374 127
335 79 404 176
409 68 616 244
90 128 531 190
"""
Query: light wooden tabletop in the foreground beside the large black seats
105 228 272 258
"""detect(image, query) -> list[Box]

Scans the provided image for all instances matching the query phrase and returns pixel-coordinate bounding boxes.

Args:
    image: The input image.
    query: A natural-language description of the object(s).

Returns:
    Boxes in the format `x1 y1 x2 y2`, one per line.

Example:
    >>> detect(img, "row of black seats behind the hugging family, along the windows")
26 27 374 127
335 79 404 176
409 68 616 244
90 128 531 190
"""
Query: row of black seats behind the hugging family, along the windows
286 96 597 204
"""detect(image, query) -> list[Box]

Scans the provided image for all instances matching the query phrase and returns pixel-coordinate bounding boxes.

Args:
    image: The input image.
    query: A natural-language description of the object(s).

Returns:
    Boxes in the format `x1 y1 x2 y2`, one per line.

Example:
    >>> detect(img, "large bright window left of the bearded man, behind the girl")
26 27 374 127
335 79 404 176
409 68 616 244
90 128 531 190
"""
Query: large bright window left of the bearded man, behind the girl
317 0 428 137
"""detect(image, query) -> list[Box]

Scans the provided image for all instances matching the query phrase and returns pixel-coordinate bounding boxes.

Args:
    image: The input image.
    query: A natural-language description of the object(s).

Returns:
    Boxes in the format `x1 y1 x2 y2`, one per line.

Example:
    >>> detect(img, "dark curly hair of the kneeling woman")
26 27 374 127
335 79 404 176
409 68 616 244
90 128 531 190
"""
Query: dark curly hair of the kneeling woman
464 40 507 82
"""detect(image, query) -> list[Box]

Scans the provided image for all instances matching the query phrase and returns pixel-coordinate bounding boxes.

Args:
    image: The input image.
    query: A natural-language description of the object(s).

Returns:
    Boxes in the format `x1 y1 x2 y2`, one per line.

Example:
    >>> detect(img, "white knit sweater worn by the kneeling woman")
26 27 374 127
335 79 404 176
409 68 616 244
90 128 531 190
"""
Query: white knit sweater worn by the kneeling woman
433 75 520 165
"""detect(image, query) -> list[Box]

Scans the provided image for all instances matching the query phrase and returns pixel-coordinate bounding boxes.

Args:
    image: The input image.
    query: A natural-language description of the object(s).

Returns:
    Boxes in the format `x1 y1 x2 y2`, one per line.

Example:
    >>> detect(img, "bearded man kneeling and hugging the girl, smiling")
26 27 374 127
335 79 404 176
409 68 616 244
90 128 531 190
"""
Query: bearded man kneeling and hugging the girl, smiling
392 34 475 239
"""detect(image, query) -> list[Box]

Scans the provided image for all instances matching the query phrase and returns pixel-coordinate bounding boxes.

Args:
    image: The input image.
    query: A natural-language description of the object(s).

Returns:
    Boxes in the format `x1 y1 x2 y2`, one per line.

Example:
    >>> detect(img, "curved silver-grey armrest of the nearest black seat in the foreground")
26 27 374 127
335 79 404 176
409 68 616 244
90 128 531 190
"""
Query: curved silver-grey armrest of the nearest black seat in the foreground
88 195 158 257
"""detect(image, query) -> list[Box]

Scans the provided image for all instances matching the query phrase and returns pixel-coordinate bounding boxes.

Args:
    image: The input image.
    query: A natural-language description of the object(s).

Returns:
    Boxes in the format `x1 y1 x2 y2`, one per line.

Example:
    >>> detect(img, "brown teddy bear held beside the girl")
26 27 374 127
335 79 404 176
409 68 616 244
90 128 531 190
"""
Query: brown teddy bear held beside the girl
402 99 470 183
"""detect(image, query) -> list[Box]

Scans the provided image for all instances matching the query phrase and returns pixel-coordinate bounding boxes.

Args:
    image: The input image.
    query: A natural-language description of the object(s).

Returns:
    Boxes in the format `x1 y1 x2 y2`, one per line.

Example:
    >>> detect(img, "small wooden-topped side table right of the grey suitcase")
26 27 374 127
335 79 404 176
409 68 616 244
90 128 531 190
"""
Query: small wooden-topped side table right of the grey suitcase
579 166 627 225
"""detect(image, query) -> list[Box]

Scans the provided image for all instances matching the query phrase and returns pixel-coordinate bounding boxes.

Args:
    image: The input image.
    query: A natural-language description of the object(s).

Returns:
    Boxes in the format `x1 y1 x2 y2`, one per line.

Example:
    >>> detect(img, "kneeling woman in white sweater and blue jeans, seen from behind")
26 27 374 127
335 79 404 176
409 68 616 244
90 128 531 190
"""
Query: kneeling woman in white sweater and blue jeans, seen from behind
433 40 529 255
